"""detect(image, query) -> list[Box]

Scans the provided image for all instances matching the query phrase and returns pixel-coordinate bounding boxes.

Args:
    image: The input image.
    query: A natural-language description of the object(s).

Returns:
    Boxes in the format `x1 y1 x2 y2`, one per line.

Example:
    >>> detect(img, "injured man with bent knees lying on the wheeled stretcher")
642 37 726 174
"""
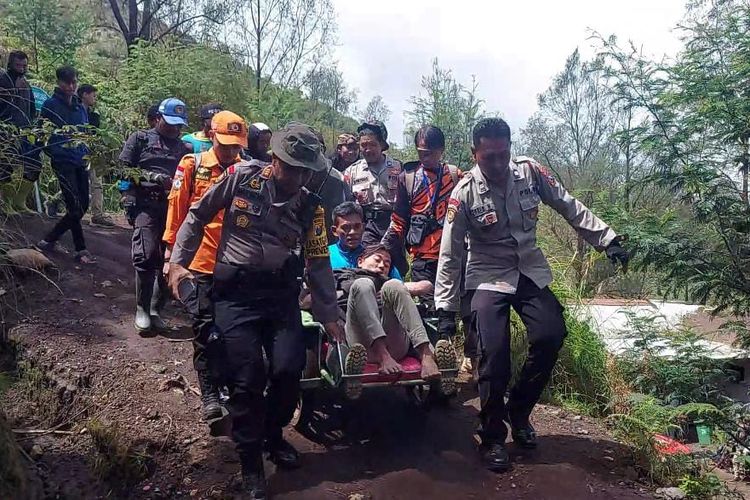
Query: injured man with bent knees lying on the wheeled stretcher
334 245 455 380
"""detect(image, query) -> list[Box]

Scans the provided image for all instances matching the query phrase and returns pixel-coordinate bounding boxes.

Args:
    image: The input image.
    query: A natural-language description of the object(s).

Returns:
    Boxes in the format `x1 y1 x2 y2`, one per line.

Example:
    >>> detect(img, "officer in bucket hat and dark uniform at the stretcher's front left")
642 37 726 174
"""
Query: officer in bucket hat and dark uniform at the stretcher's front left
169 123 344 498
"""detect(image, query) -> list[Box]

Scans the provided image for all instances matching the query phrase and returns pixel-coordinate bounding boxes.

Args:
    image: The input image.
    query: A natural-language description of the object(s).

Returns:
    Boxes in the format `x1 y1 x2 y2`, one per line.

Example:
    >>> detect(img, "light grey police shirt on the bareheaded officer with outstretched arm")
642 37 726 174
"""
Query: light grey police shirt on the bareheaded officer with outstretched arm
435 157 616 311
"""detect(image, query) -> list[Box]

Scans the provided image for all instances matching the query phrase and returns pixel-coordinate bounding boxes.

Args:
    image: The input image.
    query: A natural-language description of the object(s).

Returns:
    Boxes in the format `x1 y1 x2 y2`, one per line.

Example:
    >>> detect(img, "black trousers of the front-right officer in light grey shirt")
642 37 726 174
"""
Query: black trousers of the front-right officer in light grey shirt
471 275 567 443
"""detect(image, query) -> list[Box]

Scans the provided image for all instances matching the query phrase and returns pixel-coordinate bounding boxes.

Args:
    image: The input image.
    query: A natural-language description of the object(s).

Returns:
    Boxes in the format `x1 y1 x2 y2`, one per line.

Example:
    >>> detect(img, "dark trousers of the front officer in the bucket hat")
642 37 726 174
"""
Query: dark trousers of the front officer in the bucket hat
213 264 305 457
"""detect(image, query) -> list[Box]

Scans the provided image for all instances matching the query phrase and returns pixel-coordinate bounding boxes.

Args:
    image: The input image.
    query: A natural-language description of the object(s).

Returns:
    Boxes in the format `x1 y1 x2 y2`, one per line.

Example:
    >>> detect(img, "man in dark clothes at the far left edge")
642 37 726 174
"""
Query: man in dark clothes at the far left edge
0 50 42 212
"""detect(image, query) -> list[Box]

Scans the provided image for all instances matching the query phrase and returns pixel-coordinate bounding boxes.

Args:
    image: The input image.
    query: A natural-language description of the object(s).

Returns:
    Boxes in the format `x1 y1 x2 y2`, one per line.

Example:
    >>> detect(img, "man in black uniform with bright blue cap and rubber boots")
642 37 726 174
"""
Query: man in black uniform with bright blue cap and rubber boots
119 98 192 334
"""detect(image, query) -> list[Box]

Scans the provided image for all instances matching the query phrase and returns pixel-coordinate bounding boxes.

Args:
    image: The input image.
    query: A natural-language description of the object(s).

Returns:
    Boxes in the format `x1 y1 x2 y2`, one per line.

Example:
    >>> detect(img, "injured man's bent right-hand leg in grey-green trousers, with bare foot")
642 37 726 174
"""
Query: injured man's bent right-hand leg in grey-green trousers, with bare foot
381 280 440 378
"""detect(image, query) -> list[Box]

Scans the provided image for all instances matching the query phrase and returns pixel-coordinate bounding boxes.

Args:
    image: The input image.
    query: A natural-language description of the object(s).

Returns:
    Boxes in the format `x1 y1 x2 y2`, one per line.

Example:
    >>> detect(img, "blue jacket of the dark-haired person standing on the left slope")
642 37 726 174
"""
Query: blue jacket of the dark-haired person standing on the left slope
41 88 89 167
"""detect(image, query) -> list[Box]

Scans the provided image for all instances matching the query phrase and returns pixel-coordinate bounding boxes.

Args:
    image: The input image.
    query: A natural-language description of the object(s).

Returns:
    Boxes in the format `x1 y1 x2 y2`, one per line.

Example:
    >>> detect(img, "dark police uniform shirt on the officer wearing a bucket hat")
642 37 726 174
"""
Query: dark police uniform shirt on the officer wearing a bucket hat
170 162 338 323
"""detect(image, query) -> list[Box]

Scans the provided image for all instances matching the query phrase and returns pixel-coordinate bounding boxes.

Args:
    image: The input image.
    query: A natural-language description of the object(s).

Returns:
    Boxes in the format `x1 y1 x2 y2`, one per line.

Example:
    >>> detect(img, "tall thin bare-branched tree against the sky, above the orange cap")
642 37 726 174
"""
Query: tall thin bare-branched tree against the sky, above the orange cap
225 0 336 95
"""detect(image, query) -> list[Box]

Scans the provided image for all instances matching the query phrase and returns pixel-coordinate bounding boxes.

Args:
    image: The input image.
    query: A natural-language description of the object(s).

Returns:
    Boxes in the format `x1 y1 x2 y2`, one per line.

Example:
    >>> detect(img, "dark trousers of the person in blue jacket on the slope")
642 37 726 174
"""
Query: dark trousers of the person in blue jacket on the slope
44 162 89 252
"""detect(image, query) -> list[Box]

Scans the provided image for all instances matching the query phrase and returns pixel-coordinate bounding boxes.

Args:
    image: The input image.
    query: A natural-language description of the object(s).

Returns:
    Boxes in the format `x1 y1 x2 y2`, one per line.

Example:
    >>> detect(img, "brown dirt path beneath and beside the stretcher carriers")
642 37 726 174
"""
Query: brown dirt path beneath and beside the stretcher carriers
1 217 650 499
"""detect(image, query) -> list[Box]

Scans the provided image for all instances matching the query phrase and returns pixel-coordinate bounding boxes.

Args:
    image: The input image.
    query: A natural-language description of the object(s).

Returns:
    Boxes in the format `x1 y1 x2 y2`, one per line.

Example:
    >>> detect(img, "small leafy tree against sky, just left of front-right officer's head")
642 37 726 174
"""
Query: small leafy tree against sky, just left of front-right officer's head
405 59 485 168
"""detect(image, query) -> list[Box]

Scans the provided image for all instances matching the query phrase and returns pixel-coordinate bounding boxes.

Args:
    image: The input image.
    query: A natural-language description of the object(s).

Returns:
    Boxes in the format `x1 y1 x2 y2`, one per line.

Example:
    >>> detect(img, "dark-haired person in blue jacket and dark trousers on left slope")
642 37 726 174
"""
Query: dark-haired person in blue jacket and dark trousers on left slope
38 66 96 264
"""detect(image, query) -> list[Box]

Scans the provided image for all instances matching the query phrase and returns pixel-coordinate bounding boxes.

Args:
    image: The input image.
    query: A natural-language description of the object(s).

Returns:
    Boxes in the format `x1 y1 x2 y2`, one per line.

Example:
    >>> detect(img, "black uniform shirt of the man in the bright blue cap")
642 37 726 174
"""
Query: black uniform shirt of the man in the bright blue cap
119 128 192 177
